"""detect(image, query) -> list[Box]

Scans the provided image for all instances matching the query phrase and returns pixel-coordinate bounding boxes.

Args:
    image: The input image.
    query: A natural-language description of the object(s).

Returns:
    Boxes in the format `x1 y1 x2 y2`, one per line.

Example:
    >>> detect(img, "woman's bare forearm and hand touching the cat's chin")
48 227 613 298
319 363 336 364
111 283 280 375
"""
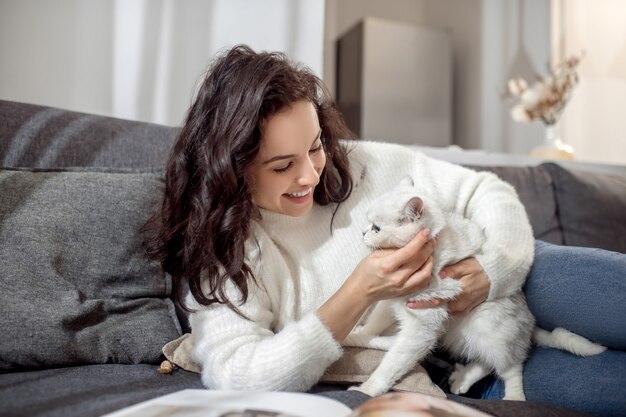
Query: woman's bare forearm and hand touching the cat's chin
317 230 435 341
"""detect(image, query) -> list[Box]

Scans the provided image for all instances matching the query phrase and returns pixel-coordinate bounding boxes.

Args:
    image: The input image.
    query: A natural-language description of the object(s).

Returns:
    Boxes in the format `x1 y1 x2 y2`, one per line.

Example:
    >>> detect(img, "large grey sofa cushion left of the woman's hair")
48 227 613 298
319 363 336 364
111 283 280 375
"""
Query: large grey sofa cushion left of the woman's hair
0 170 180 371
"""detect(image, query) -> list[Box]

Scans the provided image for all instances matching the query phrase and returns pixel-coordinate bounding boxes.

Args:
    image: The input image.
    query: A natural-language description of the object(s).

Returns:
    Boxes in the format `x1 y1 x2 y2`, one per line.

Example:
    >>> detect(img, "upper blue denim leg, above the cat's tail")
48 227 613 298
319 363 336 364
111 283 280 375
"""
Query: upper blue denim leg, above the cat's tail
524 241 626 350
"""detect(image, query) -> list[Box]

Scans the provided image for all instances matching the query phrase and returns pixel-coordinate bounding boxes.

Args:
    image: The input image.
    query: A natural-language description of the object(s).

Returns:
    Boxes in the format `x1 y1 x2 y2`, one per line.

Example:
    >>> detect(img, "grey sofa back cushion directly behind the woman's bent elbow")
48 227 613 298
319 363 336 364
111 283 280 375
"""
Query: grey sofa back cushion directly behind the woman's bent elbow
470 166 563 245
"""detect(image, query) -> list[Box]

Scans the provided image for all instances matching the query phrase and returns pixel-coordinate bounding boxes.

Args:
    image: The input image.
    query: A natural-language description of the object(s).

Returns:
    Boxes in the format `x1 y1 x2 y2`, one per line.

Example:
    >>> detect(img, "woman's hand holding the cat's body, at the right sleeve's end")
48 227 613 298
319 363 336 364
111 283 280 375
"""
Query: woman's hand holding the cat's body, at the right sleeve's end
407 258 491 314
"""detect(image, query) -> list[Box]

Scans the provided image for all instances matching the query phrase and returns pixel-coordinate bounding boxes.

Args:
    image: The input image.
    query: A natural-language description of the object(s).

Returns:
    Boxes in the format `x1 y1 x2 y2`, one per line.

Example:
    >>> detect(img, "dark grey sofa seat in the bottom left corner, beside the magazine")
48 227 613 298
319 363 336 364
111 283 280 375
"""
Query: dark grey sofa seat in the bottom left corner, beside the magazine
0 364 202 417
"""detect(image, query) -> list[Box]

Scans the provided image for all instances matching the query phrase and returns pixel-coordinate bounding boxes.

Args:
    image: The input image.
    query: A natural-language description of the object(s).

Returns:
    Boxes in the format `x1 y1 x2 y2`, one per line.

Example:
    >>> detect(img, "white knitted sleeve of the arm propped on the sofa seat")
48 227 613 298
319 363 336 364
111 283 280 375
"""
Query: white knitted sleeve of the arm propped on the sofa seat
190 232 342 391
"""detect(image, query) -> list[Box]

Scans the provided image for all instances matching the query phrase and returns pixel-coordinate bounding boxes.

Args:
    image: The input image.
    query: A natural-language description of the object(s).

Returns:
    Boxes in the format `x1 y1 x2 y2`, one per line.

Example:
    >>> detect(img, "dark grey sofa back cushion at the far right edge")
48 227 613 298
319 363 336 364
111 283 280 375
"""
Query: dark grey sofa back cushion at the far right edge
543 163 626 253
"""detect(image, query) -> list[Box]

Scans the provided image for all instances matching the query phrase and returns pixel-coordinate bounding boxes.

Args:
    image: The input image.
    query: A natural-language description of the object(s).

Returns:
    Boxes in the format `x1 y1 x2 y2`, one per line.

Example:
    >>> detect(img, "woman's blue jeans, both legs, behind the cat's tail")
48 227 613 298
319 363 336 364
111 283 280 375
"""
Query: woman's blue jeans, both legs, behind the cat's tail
481 241 626 416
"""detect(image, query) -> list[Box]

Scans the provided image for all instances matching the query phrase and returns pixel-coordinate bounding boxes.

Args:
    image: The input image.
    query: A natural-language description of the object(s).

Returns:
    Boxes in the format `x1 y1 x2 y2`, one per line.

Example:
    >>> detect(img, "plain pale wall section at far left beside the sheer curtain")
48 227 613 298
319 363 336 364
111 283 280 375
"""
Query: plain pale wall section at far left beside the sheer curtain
0 0 113 120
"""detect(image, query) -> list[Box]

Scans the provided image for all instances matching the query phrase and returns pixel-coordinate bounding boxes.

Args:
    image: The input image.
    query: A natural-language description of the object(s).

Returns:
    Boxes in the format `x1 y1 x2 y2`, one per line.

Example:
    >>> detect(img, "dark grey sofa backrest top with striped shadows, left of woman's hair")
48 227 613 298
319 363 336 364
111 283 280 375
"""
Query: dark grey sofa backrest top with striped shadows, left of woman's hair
0 100 178 172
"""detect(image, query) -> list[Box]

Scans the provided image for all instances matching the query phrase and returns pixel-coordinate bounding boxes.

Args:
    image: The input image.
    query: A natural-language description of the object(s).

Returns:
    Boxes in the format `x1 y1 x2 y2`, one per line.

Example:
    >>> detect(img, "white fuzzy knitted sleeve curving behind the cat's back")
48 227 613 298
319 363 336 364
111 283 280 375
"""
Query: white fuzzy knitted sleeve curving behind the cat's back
416 154 534 300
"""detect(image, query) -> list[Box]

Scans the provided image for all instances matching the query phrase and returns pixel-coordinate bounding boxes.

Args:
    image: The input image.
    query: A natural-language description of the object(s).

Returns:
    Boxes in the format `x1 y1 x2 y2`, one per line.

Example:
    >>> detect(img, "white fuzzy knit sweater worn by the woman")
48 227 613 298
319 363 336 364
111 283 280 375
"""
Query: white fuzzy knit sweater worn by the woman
188 142 534 391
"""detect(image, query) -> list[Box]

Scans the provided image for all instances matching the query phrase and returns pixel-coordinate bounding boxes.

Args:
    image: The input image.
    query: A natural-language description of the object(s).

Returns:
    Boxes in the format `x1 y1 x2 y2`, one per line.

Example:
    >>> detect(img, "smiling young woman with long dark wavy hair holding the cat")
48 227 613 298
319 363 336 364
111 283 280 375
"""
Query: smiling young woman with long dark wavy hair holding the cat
144 46 626 415
